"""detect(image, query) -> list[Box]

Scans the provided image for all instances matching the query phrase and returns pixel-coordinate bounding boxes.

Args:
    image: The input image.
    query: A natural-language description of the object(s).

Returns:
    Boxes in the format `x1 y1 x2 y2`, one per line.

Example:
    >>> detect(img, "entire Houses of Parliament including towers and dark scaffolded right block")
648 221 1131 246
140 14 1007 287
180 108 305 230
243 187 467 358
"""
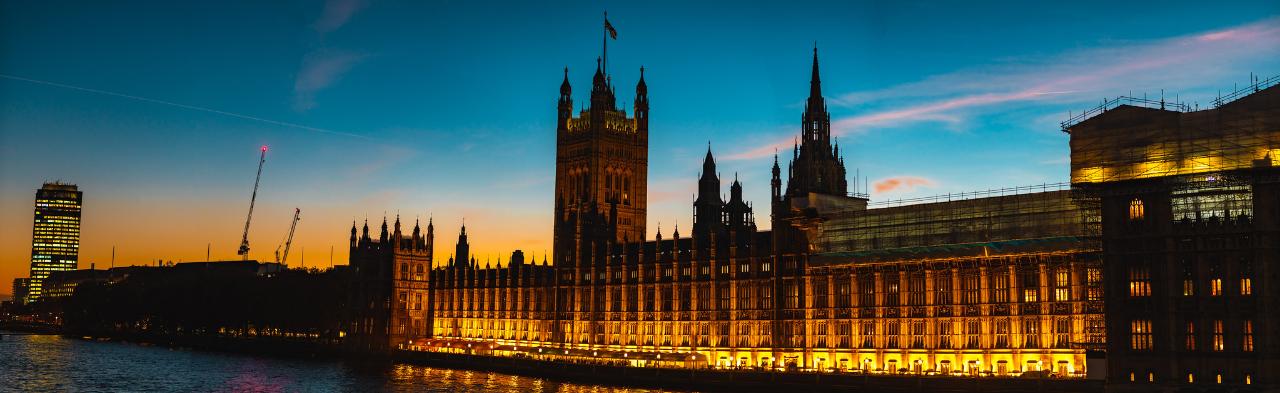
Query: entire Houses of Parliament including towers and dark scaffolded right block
347 42 1280 389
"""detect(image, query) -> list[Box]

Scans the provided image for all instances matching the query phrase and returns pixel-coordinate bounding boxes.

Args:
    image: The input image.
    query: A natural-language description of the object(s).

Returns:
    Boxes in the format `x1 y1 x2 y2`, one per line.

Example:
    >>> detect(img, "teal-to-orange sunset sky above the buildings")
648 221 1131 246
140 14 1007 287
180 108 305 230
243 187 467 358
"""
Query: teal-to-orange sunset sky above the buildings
0 0 1280 293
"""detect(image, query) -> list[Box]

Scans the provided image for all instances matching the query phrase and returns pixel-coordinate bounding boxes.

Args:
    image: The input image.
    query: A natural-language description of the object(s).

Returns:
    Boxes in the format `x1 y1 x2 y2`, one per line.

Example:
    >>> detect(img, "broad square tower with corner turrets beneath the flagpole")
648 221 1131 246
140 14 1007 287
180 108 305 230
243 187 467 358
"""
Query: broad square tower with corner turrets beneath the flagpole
553 59 649 261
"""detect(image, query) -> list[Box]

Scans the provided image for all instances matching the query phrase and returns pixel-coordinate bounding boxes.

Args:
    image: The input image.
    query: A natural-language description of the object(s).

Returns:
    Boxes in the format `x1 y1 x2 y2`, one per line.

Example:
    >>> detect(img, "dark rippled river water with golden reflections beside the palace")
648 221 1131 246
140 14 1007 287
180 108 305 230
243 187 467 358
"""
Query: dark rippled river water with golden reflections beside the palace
0 335 680 393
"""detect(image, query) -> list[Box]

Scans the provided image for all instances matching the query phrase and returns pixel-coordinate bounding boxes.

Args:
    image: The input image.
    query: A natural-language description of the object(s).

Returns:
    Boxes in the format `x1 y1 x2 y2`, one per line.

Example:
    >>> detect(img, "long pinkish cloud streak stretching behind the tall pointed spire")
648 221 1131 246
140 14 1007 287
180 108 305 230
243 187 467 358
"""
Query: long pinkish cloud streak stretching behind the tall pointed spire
727 17 1280 159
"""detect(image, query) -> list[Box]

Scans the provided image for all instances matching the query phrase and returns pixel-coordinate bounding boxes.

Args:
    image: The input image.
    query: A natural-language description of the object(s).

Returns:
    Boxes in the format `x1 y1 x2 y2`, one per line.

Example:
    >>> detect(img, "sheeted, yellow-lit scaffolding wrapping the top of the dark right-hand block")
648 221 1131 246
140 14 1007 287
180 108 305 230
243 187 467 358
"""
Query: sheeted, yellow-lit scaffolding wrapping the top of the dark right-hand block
1062 77 1280 184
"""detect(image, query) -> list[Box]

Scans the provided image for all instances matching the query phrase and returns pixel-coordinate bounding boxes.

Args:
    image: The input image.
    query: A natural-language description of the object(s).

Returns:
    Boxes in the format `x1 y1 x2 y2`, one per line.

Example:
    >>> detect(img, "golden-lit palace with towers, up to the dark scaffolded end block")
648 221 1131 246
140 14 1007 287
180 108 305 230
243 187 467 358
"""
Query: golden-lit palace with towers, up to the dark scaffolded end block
351 51 1105 378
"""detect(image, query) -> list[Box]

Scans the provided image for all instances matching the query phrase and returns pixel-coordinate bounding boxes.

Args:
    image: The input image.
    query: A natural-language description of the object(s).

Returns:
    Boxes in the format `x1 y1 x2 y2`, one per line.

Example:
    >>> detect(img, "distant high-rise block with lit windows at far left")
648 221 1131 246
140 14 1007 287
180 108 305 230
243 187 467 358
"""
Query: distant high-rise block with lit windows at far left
27 182 84 302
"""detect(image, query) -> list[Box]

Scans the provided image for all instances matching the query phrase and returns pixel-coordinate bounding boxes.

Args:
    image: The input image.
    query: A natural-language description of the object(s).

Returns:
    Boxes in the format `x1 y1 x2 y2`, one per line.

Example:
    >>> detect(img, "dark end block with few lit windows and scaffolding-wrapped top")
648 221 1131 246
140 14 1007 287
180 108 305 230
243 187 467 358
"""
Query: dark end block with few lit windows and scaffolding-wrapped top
1062 77 1280 392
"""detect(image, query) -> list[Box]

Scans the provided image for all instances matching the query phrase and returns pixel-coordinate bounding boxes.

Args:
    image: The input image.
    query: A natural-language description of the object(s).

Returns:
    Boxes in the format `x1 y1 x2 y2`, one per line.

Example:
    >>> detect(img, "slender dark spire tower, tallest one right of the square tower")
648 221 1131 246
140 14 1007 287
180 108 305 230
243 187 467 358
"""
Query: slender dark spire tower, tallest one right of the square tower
786 47 849 197
